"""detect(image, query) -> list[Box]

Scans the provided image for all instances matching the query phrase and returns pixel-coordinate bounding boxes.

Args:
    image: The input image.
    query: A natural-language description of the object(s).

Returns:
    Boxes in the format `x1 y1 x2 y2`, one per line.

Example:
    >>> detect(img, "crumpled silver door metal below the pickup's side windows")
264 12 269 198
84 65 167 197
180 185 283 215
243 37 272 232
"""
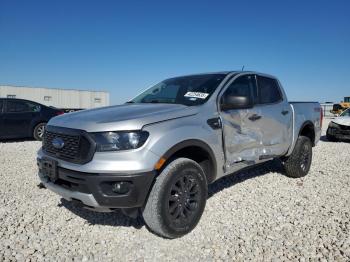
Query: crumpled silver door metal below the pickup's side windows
222 108 290 168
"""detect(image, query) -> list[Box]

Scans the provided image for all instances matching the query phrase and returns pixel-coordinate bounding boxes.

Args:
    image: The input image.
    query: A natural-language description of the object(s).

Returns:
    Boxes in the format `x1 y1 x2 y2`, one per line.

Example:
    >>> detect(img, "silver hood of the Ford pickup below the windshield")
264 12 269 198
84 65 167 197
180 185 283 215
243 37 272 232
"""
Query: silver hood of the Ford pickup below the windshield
48 104 199 132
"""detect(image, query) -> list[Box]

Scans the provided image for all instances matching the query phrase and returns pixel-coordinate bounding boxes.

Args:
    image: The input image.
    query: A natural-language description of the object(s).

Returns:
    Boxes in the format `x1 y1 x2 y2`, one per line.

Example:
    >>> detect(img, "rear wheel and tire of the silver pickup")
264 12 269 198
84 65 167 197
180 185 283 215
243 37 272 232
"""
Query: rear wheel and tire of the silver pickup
283 136 312 178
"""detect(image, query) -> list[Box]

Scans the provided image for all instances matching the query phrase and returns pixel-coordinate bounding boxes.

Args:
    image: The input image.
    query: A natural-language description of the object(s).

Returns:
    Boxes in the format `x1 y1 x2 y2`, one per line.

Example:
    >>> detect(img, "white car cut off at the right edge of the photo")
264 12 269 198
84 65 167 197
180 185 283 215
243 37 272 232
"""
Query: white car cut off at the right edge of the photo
327 108 350 142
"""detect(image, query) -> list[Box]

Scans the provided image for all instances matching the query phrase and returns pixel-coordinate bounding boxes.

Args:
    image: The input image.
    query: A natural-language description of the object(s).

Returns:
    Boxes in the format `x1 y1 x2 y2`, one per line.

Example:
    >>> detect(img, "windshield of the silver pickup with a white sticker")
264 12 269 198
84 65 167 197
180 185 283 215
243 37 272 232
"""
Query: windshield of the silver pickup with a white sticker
130 74 226 106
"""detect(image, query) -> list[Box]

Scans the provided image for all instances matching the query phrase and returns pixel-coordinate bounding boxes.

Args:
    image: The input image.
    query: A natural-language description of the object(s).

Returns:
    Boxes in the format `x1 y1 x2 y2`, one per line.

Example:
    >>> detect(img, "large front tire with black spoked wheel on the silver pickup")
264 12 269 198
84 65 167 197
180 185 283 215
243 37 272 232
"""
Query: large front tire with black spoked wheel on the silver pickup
142 158 208 238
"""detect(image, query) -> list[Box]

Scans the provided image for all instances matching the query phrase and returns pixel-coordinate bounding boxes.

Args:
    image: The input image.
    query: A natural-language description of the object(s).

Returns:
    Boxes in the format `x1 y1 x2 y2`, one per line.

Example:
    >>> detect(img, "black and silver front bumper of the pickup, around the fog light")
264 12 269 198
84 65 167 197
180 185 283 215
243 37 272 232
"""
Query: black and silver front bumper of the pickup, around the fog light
37 158 156 211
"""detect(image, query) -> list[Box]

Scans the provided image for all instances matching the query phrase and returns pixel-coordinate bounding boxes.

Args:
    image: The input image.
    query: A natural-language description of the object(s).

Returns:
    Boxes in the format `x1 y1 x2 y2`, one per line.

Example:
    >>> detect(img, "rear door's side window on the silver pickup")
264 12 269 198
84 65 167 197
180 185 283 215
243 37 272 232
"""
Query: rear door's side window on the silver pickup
258 76 282 104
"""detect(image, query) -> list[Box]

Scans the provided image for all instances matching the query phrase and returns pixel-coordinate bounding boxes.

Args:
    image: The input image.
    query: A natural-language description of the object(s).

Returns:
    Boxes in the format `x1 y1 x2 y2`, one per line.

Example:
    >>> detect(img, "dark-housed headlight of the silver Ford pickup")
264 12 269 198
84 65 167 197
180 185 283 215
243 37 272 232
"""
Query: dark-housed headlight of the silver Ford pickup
91 131 149 152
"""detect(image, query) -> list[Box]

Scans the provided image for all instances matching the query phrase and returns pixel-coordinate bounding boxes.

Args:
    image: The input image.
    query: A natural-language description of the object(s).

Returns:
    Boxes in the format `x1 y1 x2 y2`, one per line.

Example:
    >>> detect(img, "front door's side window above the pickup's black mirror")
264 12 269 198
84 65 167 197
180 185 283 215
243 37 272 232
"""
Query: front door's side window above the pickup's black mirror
223 75 255 101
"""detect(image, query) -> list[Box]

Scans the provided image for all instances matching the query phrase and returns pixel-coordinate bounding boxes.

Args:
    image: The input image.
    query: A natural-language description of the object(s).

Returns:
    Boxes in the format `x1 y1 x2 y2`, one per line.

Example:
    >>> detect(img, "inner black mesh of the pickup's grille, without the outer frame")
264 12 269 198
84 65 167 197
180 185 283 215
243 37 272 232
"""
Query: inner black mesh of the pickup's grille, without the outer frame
44 131 80 160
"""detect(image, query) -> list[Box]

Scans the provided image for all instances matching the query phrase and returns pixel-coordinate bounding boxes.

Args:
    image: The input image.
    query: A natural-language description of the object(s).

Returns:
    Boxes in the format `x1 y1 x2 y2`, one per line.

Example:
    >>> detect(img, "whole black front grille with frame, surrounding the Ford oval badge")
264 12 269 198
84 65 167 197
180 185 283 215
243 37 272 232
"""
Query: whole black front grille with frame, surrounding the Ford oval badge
43 126 95 164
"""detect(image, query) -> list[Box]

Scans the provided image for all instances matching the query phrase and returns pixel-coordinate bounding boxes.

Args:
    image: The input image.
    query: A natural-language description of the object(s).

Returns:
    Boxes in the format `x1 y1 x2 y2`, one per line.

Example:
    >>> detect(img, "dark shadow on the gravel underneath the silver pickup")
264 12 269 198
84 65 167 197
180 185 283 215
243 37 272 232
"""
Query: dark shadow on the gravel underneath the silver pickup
59 160 283 229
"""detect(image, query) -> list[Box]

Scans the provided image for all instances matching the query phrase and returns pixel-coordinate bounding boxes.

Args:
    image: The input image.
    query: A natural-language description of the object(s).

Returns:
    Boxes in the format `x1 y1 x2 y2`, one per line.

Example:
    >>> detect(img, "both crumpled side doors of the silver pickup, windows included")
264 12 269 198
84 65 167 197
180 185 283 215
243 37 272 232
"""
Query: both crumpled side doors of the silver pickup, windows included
220 75 292 170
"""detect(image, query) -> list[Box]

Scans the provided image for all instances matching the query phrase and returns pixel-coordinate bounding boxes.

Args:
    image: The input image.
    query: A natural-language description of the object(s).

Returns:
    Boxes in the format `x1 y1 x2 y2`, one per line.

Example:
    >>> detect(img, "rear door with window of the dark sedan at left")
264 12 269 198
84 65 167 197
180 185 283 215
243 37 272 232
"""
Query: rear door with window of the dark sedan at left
3 99 41 138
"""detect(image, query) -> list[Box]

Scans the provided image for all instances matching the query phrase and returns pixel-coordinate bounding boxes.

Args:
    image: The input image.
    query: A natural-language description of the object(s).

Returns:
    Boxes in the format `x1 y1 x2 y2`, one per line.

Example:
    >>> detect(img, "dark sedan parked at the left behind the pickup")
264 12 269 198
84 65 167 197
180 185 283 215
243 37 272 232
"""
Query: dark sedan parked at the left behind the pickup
0 98 63 140
